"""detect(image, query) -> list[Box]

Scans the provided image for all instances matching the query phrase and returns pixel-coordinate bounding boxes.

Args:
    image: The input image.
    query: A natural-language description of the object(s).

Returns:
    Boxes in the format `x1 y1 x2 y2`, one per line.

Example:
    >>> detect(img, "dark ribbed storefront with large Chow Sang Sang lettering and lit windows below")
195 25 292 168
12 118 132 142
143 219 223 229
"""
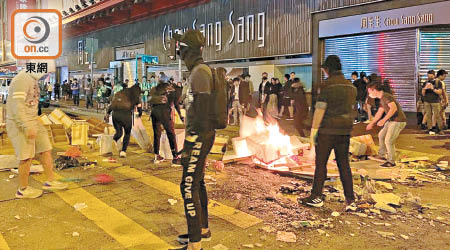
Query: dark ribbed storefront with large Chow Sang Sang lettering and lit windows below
59 0 315 91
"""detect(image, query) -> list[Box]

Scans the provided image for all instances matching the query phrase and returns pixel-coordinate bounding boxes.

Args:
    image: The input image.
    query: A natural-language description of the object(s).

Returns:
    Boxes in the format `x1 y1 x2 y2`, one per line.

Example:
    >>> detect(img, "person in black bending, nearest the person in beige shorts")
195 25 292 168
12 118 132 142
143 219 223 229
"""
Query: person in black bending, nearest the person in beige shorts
105 84 142 158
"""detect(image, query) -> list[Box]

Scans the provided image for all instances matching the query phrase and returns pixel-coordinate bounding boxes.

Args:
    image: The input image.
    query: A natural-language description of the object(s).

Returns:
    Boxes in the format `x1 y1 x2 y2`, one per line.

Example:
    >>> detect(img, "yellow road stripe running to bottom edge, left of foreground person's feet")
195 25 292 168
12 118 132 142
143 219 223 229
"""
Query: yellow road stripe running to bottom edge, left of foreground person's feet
34 174 171 250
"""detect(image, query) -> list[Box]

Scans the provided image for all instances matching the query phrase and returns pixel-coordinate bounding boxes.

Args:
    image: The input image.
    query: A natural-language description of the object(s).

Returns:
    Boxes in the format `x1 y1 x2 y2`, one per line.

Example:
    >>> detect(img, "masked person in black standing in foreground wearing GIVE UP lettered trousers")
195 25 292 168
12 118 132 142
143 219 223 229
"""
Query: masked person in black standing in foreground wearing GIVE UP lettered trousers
174 30 215 250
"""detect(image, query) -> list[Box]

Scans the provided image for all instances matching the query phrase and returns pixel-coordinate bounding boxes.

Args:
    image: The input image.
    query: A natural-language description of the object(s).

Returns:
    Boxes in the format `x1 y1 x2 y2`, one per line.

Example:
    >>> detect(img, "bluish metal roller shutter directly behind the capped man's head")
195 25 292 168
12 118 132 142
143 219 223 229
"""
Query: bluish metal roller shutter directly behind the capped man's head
323 29 418 112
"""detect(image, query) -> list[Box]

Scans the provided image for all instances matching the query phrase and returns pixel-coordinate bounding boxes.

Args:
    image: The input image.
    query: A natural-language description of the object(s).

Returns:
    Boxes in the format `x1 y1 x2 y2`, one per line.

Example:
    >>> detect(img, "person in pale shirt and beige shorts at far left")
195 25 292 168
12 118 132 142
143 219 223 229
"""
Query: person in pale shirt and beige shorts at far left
6 60 67 198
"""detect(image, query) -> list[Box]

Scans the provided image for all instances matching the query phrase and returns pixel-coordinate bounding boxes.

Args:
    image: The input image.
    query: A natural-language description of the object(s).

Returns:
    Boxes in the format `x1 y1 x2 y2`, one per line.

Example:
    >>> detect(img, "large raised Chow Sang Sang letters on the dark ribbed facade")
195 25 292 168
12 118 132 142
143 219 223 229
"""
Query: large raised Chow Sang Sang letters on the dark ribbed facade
162 11 266 51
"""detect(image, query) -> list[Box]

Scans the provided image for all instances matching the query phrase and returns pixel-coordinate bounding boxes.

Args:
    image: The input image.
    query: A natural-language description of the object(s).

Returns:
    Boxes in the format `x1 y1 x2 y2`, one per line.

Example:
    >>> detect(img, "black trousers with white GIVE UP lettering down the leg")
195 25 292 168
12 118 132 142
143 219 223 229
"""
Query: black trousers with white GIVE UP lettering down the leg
180 130 216 242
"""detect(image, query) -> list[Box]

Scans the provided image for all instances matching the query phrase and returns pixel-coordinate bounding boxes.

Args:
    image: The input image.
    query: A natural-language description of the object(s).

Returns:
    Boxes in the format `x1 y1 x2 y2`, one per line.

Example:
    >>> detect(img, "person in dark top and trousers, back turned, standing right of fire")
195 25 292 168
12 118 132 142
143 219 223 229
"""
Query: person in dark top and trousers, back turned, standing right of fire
299 55 357 210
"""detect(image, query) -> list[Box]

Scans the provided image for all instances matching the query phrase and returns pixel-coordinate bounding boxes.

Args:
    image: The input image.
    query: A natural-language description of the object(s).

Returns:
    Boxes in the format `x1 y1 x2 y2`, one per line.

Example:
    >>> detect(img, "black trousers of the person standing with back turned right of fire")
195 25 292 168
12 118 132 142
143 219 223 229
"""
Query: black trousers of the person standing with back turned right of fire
311 133 355 202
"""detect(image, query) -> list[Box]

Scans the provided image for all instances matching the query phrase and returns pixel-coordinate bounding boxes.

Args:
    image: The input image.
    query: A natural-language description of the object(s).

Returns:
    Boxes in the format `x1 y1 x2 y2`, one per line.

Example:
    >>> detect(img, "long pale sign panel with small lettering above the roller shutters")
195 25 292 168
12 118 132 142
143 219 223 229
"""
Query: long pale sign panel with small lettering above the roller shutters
319 1 450 38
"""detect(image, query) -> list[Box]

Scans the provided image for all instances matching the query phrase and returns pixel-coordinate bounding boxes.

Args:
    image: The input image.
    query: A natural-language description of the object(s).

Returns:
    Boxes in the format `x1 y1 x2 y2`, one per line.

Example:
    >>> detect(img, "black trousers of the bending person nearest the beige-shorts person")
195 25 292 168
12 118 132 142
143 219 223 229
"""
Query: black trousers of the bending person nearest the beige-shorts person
112 111 133 152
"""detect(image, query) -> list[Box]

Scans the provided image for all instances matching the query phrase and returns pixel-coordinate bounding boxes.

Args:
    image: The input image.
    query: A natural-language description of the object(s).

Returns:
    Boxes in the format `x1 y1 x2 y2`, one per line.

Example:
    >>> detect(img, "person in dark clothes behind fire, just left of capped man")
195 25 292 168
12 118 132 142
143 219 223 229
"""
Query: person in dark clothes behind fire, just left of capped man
292 78 308 137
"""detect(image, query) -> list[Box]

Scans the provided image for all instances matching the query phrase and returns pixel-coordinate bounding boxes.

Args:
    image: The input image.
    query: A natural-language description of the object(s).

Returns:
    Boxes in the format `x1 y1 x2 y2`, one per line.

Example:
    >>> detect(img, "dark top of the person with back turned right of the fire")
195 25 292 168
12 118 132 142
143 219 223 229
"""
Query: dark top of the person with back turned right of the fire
316 72 357 135
